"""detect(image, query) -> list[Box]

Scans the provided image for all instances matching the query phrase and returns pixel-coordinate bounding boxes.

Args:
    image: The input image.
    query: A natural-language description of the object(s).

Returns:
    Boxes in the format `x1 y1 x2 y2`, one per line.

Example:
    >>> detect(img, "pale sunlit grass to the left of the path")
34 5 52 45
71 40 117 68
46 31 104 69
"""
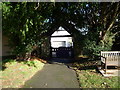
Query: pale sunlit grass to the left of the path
0 60 44 88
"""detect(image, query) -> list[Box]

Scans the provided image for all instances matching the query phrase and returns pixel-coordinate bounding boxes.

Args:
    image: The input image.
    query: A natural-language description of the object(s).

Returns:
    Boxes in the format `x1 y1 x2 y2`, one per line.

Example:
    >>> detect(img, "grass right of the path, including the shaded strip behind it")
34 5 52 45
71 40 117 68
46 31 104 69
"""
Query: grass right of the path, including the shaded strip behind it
72 62 120 88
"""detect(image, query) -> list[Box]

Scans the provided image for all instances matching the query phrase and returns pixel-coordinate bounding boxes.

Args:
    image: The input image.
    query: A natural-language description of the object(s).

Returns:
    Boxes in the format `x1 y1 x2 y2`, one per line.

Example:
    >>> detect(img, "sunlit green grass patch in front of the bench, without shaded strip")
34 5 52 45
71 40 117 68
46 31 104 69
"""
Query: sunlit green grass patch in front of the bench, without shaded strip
78 70 120 88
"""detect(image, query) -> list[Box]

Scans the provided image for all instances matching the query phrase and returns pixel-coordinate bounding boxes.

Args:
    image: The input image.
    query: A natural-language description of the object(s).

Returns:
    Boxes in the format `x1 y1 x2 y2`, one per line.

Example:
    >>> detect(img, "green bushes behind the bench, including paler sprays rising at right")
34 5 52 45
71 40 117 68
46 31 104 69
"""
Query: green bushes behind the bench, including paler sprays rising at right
83 33 114 57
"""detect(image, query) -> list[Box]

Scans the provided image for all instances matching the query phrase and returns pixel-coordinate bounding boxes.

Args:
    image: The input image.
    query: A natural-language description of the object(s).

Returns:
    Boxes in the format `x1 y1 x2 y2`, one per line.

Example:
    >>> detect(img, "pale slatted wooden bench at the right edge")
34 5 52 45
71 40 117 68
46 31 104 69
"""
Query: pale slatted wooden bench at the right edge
101 51 120 73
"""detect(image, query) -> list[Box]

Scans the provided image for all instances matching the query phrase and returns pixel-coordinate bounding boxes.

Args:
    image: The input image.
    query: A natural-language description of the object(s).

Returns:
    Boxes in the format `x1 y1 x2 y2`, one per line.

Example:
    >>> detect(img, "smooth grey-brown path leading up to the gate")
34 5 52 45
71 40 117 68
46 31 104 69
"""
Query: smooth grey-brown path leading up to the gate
23 63 79 88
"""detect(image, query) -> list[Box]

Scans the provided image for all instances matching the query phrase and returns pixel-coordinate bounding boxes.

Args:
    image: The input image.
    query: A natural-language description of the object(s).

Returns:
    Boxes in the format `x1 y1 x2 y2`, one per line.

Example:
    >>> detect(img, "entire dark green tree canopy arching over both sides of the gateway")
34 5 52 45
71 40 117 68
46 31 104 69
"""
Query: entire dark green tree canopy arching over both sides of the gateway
2 2 120 58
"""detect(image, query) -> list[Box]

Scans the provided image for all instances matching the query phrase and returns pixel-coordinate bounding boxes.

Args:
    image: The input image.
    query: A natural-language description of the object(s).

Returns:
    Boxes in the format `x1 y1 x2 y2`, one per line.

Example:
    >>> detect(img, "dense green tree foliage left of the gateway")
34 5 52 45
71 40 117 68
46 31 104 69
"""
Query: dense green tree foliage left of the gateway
3 2 50 55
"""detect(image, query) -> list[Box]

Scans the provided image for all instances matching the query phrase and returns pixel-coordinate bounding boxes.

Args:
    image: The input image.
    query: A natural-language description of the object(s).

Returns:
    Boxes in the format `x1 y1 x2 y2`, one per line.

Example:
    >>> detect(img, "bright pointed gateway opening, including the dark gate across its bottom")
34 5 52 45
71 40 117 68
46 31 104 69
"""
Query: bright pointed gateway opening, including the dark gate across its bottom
51 27 73 58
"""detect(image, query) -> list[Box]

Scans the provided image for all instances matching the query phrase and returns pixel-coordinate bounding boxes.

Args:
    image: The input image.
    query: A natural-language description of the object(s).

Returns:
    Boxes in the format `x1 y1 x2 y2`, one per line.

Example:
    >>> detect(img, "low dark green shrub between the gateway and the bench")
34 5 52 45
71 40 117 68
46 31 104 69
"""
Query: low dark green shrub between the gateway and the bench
83 34 113 58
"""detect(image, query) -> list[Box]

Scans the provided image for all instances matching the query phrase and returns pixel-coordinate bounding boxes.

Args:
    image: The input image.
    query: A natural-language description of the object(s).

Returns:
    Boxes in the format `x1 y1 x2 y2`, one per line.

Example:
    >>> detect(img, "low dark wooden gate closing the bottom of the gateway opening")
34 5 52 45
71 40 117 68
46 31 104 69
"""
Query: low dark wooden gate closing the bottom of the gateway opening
51 47 73 58
